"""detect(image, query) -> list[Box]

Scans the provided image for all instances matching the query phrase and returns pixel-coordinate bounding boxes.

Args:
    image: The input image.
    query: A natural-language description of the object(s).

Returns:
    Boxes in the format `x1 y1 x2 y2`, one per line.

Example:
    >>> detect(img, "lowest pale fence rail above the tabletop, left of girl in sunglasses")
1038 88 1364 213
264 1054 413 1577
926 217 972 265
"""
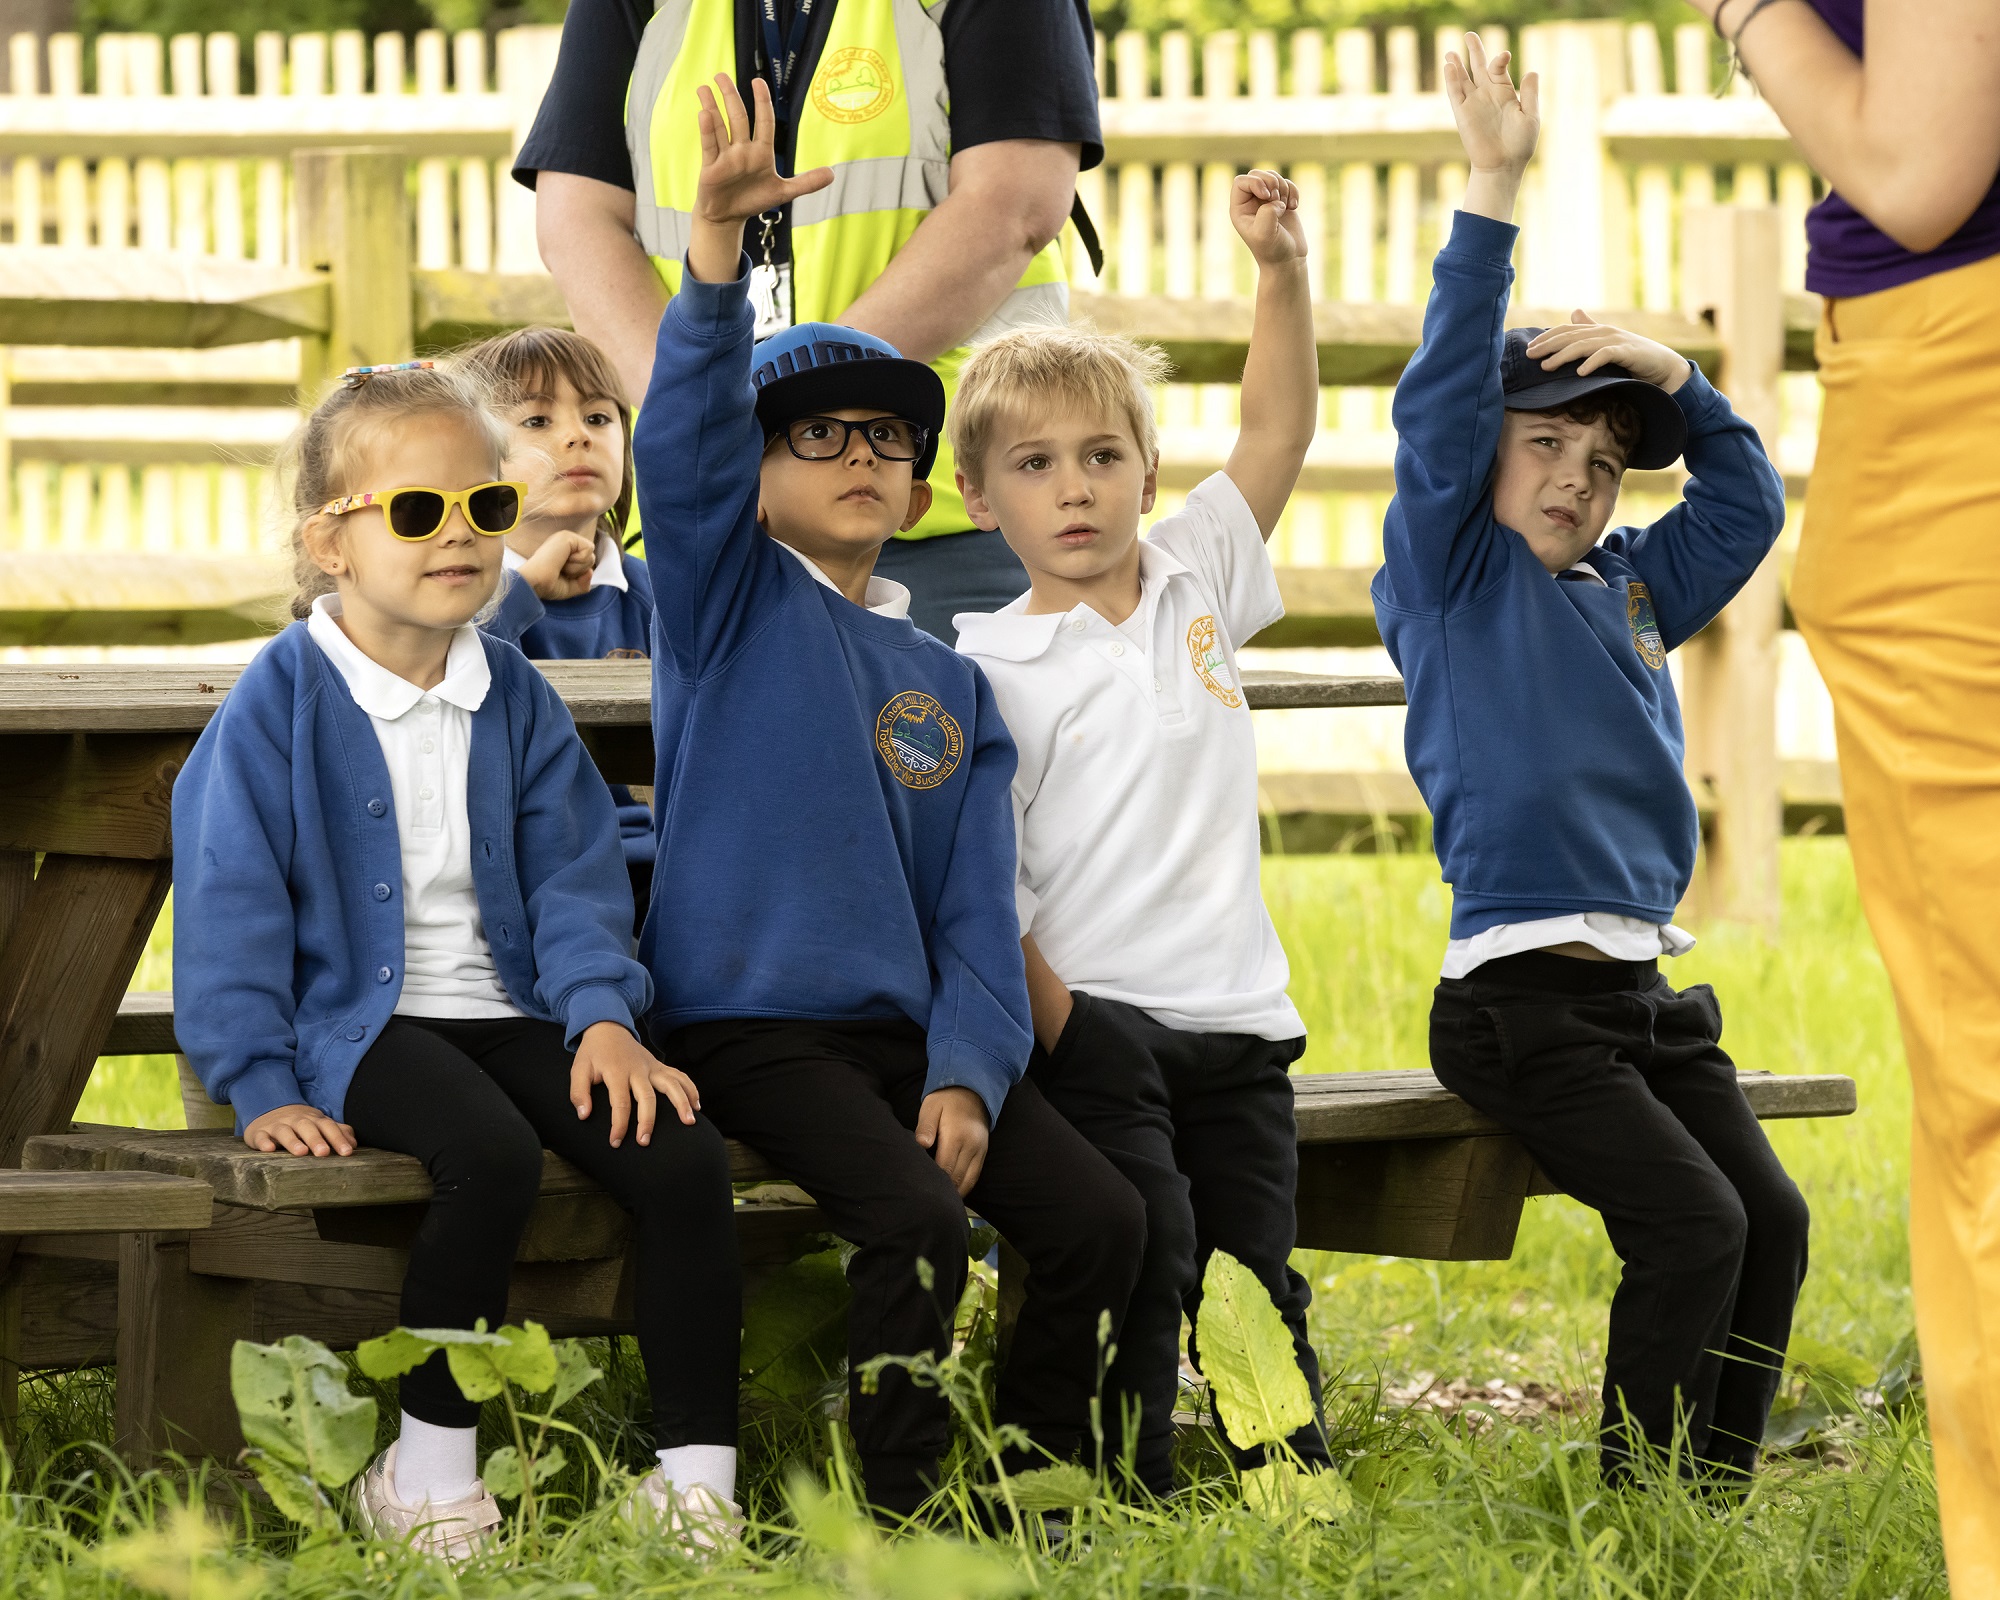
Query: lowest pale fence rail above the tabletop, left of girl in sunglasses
0 552 292 646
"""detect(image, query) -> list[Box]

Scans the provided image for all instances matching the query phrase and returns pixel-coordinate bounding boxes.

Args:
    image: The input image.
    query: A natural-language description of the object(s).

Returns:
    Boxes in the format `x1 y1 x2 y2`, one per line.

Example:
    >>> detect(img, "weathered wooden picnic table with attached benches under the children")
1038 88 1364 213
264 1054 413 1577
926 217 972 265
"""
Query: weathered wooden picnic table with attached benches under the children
0 662 1854 1460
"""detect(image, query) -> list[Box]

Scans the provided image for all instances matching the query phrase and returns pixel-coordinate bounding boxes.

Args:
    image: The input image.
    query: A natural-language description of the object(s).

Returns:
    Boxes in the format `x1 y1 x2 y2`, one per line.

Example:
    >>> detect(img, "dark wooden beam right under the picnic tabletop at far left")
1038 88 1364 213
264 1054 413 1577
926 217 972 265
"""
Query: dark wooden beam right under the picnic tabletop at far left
0 734 194 860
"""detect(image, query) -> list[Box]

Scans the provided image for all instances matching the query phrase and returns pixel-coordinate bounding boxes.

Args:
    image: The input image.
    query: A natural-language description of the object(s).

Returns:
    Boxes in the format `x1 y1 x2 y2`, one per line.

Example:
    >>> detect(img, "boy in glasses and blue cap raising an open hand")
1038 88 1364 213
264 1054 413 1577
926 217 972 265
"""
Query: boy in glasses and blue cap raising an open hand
634 78 1146 1516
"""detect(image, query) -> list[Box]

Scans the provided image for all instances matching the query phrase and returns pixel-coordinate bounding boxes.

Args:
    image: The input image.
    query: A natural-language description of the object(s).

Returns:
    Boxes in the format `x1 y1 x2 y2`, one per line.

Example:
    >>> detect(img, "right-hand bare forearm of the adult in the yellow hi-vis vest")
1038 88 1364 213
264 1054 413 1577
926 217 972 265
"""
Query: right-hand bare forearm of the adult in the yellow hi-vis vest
840 138 1082 362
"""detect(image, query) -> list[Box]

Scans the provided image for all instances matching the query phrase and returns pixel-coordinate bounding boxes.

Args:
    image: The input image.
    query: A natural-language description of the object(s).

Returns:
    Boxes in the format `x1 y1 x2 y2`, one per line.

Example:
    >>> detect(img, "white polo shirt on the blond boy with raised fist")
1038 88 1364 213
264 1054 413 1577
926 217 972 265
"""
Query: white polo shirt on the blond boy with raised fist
952 472 1306 1040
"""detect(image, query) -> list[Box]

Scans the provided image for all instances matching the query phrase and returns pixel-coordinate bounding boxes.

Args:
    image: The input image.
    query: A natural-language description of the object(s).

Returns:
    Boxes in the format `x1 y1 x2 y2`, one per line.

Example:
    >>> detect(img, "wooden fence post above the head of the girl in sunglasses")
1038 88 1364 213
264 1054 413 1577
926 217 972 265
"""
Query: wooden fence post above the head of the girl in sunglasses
292 150 416 400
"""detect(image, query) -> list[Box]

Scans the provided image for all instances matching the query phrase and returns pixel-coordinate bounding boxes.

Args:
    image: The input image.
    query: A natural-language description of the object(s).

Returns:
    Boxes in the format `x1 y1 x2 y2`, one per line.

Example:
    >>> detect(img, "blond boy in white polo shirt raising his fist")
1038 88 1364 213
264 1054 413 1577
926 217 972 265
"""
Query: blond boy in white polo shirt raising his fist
946 172 1326 1496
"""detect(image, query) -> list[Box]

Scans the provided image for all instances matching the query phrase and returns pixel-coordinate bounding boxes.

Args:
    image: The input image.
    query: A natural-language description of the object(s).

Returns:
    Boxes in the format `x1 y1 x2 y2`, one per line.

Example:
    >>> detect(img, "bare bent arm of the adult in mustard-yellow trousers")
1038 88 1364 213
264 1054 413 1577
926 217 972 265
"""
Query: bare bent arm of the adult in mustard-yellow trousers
1692 0 2000 250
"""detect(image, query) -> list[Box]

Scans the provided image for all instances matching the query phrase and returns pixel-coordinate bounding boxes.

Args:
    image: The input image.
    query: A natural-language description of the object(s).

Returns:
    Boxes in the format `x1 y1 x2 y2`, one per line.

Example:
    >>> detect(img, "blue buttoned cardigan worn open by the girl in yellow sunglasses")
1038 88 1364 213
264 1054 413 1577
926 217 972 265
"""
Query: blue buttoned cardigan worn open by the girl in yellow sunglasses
174 622 652 1132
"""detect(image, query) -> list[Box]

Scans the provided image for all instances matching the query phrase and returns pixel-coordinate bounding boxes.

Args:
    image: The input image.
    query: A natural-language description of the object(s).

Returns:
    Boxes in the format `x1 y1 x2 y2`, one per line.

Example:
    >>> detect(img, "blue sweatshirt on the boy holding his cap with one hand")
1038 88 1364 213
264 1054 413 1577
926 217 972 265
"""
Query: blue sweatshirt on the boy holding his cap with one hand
1374 212 1784 938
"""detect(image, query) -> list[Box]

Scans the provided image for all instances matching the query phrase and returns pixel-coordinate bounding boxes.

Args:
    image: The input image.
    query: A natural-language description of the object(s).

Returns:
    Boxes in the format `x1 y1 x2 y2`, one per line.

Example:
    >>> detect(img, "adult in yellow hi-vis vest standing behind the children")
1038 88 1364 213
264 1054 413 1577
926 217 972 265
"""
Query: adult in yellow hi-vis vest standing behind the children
514 0 1102 642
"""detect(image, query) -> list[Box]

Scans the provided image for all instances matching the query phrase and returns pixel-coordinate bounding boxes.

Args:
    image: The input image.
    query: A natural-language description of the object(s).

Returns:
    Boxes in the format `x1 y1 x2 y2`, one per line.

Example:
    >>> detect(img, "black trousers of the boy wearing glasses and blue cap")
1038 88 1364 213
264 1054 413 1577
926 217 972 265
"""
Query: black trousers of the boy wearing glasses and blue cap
660 1020 1146 1514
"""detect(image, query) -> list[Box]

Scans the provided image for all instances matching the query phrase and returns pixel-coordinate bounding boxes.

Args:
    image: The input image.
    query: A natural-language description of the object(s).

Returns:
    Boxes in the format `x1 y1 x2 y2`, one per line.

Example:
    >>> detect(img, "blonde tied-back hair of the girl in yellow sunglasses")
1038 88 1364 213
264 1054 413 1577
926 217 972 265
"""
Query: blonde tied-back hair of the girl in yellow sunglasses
278 364 508 618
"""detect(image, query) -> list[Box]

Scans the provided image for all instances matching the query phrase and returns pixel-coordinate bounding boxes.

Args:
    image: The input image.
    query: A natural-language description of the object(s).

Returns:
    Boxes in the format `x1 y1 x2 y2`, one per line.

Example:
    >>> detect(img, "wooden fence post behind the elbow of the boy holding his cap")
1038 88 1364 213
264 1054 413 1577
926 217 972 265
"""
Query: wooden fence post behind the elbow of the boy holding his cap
1682 206 1784 932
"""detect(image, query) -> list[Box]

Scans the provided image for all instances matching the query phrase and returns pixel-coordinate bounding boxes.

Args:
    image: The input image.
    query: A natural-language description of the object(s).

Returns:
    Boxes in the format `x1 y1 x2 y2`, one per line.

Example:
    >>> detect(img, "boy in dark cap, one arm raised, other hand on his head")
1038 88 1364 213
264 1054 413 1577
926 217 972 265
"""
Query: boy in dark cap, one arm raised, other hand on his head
1374 34 1808 1482
